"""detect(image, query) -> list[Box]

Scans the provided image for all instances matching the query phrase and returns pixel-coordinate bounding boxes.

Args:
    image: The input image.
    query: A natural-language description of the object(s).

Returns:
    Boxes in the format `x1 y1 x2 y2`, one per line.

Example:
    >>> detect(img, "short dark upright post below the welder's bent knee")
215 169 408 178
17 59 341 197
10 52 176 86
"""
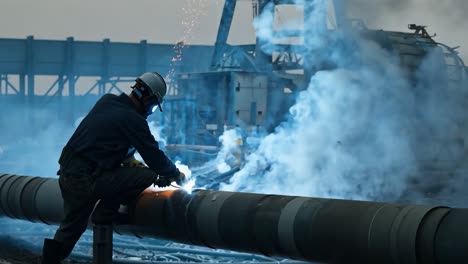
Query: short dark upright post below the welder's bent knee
93 225 113 264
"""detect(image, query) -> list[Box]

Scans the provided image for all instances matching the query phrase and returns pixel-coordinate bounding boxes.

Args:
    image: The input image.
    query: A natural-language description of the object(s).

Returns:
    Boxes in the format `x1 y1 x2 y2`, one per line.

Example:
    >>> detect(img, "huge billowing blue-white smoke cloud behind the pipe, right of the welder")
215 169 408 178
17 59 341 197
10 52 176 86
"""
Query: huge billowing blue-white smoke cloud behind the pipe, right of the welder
221 0 464 200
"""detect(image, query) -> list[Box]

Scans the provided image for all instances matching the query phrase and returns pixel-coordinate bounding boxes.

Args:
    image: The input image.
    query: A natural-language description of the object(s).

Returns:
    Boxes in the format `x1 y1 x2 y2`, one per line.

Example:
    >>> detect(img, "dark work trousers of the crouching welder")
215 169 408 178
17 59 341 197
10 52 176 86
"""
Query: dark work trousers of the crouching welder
54 164 157 259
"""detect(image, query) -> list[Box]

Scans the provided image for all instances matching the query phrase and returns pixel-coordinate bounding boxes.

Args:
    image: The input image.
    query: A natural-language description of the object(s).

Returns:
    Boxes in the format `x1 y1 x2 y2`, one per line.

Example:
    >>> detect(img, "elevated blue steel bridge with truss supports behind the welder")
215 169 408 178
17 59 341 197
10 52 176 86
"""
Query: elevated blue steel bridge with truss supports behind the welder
0 36 213 97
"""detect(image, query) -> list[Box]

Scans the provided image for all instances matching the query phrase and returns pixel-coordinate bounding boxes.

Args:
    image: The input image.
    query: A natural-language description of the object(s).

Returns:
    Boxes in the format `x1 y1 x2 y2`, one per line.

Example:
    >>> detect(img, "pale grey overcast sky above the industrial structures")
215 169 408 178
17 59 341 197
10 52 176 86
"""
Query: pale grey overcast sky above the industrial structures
0 0 468 61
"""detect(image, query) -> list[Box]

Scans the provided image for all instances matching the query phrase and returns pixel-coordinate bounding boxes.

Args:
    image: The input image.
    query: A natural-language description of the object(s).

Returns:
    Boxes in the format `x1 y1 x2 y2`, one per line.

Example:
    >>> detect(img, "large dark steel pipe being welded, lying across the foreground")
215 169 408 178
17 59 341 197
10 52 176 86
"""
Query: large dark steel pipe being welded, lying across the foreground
0 174 468 264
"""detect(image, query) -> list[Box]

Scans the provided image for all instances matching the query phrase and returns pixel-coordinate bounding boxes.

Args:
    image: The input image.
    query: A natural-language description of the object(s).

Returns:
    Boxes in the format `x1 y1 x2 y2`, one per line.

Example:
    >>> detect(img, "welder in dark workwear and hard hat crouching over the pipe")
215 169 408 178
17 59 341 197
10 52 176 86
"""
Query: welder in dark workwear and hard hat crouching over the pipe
42 72 185 264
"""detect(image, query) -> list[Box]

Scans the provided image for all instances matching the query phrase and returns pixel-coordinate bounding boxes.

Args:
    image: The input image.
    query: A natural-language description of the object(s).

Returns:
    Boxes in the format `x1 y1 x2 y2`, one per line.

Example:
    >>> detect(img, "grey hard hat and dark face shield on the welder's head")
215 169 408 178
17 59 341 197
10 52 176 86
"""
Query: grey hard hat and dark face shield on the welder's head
133 72 167 115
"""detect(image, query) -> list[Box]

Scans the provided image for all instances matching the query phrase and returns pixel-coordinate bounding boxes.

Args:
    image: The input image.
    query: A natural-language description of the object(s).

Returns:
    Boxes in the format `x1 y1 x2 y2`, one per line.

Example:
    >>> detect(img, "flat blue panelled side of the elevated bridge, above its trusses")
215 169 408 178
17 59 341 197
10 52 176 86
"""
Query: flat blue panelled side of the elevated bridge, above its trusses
0 38 213 77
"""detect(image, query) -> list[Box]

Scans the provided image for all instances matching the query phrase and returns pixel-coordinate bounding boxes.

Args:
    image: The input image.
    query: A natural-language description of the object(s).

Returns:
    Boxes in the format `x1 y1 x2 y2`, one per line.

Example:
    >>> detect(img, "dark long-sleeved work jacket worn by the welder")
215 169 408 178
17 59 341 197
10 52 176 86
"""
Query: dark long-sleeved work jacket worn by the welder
65 94 179 177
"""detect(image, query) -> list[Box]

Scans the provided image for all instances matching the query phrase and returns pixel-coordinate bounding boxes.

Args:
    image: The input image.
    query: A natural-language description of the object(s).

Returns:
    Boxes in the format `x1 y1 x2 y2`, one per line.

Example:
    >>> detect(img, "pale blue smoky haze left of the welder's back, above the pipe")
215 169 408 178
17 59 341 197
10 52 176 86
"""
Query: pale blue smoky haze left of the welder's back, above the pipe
0 101 79 177
